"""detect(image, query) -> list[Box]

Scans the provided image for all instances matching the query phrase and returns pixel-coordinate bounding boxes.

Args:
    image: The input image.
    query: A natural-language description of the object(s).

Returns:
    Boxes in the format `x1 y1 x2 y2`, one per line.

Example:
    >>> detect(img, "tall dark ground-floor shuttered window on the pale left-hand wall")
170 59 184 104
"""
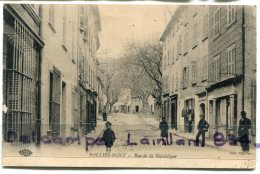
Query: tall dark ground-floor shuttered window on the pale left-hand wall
49 67 61 136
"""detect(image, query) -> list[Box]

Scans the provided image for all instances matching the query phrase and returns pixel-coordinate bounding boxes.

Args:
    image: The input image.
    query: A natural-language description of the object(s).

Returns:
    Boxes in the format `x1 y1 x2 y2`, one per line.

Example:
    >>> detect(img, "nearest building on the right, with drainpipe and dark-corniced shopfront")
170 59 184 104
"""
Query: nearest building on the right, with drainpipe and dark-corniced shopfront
207 6 256 140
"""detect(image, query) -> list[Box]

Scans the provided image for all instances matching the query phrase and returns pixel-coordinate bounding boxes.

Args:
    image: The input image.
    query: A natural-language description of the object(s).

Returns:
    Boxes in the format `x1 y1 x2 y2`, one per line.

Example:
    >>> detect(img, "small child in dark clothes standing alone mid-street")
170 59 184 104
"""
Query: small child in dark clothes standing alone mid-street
103 121 116 152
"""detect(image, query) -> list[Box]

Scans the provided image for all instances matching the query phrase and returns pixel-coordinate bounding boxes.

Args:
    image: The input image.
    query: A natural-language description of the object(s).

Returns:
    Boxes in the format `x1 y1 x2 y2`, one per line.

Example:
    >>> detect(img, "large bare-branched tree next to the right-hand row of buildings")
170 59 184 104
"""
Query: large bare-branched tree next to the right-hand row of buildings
126 41 163 107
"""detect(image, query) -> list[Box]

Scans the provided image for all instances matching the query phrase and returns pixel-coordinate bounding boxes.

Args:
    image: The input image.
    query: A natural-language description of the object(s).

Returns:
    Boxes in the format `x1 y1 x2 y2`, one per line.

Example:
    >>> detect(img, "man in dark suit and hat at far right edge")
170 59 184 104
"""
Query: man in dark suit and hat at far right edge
238 111 251 151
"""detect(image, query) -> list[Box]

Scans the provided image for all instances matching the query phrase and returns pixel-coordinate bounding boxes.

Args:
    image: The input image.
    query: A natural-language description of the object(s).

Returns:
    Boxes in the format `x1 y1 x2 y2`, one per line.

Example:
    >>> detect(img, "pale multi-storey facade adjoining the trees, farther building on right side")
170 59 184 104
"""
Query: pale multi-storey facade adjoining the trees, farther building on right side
161 6 209 133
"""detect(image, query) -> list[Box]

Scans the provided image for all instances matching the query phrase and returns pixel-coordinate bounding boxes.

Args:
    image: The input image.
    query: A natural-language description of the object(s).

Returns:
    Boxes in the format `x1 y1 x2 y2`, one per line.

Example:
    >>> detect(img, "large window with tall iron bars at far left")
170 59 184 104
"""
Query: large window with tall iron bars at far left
5 20 38 143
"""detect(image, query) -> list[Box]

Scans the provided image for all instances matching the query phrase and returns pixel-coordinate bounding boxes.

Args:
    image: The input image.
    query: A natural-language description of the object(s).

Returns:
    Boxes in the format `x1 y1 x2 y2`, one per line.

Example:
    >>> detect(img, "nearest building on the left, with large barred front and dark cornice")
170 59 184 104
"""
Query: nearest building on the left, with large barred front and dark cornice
3 4 44 144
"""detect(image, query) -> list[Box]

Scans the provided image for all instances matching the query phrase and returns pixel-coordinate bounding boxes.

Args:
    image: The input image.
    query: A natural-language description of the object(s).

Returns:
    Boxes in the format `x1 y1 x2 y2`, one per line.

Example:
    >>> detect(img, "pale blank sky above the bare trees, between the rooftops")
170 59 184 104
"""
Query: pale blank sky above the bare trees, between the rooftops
97 5 176 59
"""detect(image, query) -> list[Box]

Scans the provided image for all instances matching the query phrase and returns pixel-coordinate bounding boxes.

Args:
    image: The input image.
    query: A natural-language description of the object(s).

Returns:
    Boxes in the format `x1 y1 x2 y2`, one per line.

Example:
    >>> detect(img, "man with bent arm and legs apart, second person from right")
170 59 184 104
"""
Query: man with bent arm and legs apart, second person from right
196 115 209 147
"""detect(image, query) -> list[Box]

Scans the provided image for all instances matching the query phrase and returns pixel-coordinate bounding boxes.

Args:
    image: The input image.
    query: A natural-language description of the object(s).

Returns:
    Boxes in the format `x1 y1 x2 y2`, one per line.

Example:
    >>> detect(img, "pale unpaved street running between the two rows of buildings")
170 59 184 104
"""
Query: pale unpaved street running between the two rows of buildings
3 113 248 162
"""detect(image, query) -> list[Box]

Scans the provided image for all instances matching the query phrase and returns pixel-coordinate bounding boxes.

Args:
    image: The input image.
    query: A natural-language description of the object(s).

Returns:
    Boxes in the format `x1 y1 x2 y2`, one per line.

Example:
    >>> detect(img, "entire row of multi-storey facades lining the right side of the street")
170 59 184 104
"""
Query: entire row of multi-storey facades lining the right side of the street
161 6 256 140
